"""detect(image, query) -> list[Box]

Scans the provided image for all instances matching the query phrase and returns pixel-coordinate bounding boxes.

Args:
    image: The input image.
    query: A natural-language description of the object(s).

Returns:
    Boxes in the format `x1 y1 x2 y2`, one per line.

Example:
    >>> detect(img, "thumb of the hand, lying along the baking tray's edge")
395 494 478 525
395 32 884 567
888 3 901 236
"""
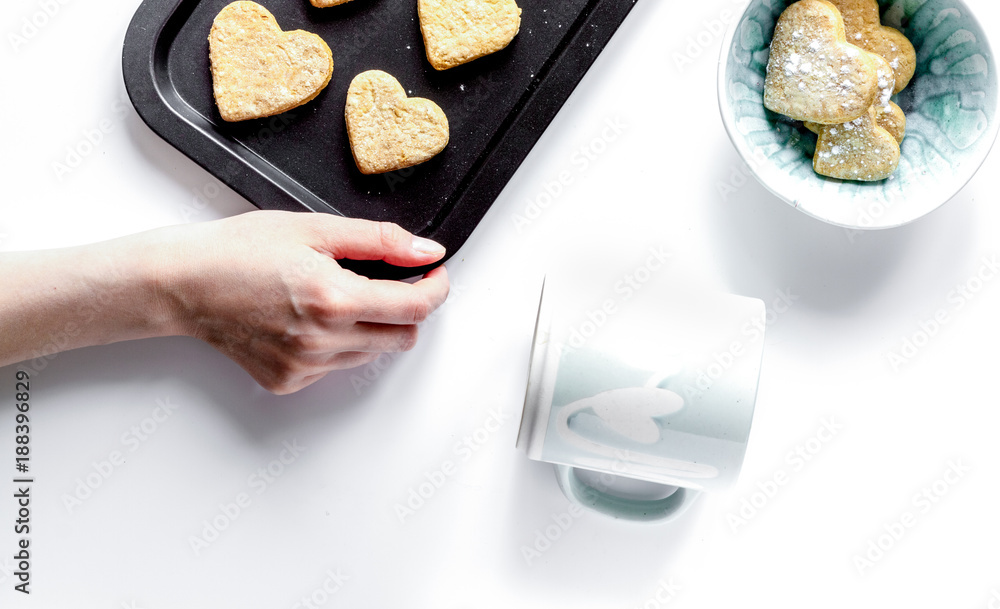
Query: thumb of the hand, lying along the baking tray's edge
304 214 445 266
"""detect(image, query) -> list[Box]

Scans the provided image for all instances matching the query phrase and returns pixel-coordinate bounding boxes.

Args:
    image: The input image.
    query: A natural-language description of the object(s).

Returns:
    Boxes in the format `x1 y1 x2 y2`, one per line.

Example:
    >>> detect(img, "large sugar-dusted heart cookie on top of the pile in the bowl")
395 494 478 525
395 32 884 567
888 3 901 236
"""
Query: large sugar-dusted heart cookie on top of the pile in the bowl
764 0 881 125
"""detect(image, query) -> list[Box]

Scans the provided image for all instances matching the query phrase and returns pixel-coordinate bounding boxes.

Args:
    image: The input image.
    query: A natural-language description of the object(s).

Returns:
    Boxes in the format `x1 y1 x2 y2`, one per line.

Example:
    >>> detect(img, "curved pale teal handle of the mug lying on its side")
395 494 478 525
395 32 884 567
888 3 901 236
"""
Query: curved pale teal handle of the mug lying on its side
554 464 700 522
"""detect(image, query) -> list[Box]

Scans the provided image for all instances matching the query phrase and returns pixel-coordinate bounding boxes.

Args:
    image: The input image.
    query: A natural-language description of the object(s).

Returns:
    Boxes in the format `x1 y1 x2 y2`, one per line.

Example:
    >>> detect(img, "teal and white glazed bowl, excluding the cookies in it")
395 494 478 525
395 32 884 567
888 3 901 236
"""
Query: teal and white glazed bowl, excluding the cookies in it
718 0 1000 229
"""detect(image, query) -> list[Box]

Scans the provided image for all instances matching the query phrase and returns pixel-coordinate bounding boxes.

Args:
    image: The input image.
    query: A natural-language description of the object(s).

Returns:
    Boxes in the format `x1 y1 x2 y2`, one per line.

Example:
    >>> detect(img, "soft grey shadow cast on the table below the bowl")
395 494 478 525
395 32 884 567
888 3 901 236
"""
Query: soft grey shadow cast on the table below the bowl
706 141 975 316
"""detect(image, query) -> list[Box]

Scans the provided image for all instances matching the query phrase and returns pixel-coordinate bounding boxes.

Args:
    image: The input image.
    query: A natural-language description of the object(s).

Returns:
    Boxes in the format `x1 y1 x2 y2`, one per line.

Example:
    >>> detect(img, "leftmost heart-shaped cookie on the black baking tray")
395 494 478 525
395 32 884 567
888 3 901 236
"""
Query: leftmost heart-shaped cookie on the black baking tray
208 1 333 121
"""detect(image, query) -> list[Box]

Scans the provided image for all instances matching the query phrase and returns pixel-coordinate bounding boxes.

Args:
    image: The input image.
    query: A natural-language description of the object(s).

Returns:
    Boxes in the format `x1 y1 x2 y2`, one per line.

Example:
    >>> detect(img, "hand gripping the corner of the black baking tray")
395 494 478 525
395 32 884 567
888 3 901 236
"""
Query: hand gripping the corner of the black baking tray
154 211 449 394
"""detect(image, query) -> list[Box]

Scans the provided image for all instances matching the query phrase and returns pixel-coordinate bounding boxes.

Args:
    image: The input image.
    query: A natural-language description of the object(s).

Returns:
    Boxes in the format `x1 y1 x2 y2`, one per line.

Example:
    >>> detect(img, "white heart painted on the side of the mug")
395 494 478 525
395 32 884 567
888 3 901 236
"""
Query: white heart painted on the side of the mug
572 387 684 444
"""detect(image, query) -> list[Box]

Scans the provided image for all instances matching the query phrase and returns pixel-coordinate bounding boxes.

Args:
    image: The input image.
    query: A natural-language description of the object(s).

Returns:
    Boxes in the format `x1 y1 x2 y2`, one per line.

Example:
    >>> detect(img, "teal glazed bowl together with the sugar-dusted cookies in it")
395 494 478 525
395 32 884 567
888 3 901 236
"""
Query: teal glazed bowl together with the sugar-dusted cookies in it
718 0 1000 229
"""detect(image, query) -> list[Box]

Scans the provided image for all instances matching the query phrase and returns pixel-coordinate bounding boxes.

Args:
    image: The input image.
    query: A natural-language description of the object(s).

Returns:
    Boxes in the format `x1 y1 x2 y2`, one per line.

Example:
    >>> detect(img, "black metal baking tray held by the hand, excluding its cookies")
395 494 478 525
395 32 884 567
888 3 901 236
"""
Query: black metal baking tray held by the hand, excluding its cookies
122 0 636 278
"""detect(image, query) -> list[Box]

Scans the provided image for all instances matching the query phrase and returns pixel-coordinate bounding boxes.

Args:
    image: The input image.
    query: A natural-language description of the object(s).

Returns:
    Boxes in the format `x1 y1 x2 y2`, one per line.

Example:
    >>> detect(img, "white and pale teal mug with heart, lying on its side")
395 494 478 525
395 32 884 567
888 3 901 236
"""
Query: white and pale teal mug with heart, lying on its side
517 277 766 521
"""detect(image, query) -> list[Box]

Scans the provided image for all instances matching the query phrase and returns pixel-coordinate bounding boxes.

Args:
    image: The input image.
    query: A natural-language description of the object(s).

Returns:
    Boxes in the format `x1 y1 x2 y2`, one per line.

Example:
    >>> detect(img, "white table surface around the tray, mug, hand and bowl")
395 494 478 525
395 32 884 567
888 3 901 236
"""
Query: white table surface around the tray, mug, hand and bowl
0 0 1000 609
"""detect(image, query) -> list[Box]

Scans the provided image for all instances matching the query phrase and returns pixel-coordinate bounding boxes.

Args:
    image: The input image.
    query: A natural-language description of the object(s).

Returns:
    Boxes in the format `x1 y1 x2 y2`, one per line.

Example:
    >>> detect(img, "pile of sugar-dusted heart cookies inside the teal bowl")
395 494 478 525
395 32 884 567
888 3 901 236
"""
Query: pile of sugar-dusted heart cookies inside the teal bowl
764 0 916 181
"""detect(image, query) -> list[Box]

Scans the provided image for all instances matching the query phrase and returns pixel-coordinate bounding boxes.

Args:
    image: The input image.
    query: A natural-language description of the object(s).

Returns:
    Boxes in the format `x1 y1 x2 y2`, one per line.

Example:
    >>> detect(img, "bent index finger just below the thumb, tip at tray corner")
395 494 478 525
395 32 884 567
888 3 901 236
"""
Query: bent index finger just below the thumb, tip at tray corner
350 266 450 325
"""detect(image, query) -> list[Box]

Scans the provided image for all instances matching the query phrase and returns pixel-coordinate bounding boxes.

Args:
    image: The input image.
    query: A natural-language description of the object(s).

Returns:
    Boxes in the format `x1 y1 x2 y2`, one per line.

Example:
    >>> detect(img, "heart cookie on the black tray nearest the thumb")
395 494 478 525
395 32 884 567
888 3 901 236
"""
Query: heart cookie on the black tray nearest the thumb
344 70 448 174
